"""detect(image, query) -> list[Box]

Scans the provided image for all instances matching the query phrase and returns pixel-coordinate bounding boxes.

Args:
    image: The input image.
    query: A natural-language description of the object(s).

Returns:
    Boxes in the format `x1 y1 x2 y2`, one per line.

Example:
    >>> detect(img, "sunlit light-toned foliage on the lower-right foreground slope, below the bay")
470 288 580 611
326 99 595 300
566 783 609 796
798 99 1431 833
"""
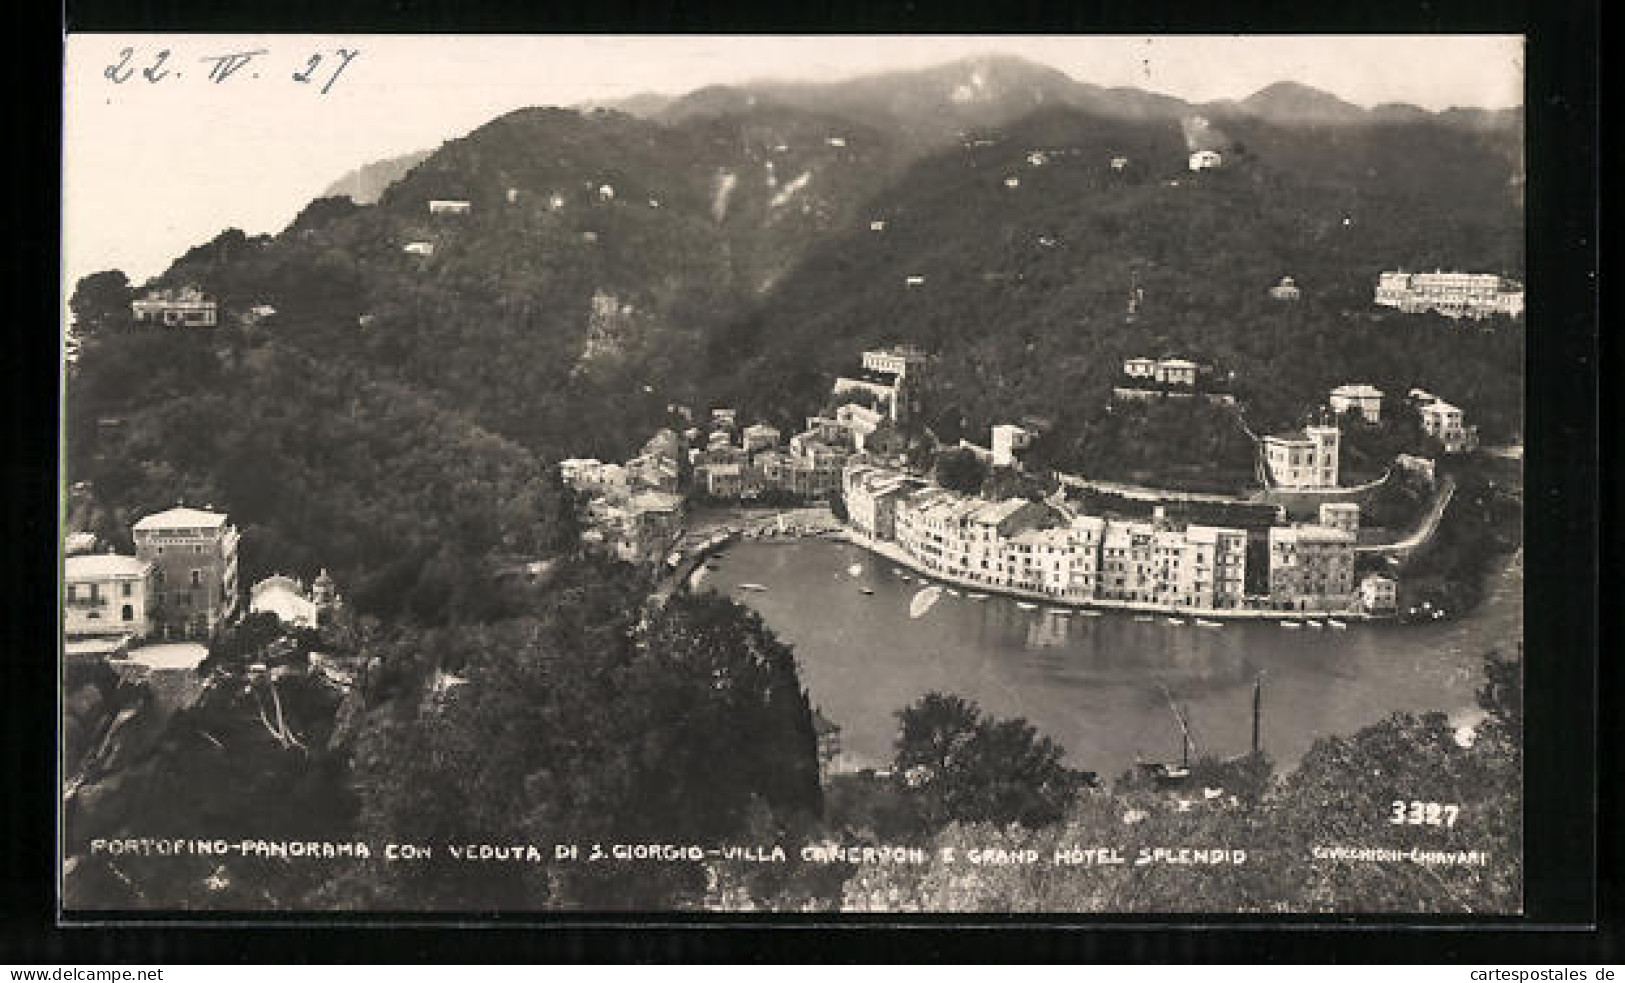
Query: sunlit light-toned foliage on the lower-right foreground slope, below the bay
843 655 1523 915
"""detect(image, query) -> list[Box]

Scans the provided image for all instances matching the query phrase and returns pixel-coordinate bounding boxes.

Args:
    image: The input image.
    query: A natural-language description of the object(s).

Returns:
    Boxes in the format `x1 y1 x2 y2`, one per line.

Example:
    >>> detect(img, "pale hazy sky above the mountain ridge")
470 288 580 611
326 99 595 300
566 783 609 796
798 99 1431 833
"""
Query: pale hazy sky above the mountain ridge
62 34 1523 298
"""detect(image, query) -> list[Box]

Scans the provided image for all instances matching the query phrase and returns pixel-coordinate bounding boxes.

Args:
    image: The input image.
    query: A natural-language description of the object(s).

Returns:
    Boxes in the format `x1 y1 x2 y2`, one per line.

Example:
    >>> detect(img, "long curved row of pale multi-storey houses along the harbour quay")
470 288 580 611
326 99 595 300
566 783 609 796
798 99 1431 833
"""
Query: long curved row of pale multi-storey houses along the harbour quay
843 463 1398 614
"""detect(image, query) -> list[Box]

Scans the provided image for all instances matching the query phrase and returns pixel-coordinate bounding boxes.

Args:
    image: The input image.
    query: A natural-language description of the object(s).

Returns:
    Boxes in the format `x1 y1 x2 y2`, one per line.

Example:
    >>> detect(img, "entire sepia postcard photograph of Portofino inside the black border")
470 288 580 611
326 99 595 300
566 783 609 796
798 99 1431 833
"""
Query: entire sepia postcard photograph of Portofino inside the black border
57 32 1527 920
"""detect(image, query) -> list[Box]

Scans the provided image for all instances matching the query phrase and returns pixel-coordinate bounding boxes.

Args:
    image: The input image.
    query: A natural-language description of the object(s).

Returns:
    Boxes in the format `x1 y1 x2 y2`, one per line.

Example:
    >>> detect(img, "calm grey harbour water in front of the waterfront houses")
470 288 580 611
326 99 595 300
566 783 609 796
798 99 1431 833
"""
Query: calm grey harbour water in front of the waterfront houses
699 541 1523 780
